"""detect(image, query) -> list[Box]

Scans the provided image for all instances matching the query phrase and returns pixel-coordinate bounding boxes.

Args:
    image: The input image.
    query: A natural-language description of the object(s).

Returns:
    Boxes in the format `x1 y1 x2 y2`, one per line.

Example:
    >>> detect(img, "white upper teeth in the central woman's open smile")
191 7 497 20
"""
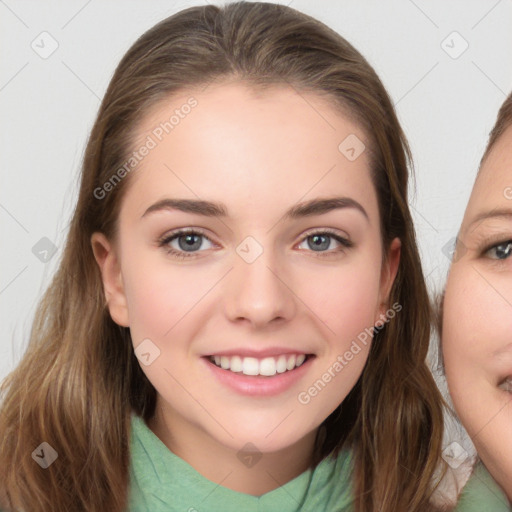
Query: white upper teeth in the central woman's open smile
210 354 306 377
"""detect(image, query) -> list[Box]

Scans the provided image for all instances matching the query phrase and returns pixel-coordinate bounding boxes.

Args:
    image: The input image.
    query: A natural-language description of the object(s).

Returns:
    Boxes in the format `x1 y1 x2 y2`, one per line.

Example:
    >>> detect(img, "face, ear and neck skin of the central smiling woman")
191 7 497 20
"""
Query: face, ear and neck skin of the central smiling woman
91 81 400 495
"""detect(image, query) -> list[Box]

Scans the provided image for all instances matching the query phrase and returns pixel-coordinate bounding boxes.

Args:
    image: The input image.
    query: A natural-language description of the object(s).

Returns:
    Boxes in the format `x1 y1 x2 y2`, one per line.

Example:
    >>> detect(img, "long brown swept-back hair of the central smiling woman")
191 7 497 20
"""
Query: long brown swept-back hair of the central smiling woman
0 2 443 512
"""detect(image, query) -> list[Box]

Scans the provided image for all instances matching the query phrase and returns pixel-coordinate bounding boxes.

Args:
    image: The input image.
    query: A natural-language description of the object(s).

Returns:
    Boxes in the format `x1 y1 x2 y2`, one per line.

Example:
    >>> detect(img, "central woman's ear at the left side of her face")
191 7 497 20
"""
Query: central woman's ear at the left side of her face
91 232 130 327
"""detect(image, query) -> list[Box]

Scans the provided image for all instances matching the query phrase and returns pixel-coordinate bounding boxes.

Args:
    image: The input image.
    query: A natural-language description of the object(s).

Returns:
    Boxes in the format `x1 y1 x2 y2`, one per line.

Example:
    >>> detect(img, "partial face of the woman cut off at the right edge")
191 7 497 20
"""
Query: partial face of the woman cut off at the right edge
442 128 512 501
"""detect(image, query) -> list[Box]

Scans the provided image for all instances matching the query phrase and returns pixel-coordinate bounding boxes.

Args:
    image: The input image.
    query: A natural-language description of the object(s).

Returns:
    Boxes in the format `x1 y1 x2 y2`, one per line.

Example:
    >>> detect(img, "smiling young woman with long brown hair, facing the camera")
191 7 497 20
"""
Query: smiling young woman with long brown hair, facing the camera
0 2 504 512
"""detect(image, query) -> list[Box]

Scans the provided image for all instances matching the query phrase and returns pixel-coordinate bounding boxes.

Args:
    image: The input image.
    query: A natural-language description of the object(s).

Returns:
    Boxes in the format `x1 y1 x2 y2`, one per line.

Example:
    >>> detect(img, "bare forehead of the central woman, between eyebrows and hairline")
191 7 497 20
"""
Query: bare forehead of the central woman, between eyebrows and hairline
119 82 376 221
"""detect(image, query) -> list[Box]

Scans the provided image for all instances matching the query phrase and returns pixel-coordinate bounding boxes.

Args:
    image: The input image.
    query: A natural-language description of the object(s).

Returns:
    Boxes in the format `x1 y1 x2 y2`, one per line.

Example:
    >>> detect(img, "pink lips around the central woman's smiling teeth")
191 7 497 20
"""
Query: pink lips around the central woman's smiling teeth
201 356 315 397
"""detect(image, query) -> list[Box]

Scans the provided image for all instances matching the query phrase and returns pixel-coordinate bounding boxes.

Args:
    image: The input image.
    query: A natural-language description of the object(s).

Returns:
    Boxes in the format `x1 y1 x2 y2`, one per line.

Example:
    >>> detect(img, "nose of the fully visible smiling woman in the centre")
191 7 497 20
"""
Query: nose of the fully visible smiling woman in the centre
224 244 297 328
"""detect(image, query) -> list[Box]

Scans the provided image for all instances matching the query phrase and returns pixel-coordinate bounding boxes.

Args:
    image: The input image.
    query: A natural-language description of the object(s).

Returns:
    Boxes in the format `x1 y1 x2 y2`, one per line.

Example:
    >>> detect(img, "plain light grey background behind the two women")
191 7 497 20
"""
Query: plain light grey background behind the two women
0 0 512 378
